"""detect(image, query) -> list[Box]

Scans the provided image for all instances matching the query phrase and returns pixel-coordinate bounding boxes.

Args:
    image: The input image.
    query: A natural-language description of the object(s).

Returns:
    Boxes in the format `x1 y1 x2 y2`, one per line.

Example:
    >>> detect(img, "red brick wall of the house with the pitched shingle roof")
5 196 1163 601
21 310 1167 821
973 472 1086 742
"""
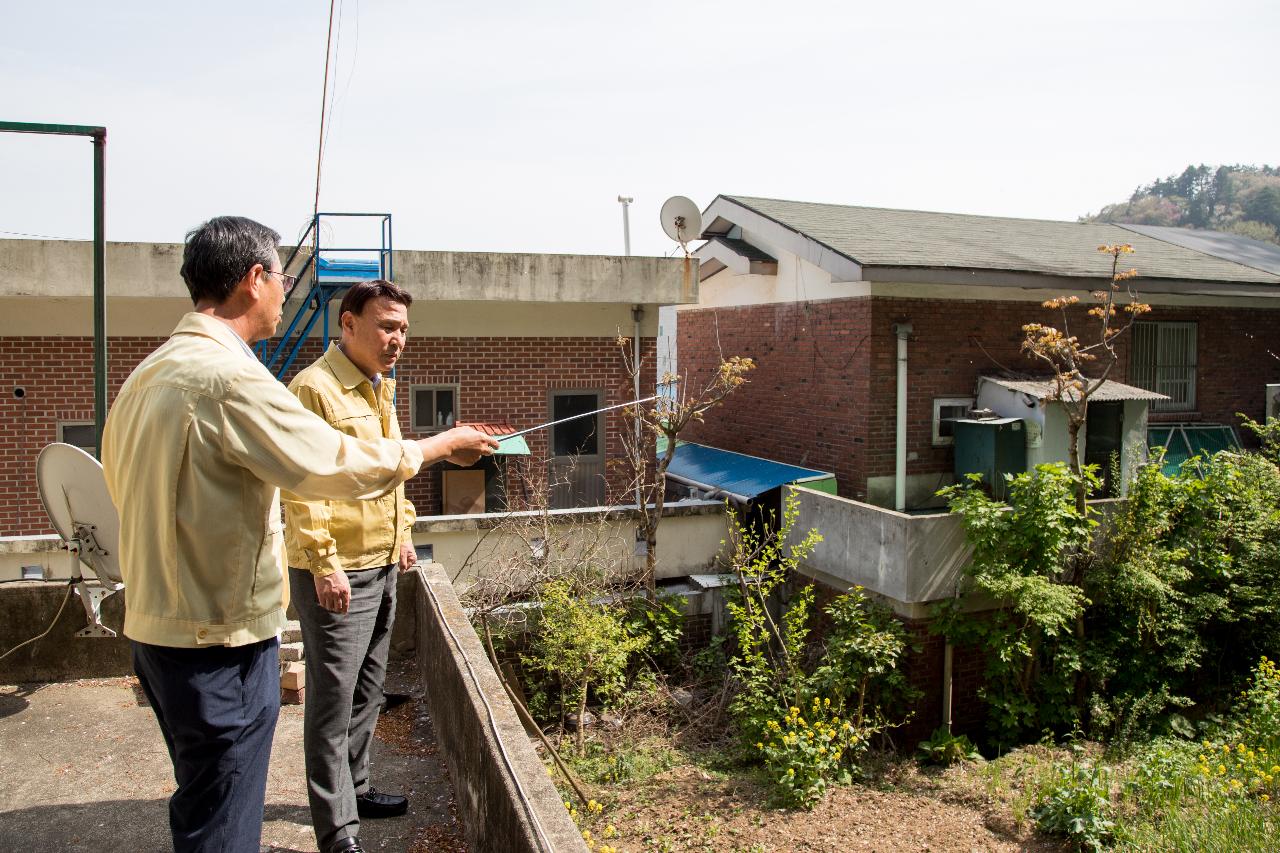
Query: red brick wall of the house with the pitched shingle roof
677 297 1280 498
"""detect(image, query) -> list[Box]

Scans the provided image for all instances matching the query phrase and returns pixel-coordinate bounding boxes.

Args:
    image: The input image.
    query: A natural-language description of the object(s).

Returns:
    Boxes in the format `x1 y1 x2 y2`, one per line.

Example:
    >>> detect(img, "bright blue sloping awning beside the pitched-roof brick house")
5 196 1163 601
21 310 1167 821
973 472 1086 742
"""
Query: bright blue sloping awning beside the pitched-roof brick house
667 442 836 503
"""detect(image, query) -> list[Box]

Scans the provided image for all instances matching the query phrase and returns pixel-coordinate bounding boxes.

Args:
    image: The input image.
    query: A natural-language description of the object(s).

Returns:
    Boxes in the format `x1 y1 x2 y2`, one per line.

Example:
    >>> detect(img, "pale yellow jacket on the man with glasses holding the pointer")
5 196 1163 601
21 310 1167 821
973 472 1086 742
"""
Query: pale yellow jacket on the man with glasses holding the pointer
102 314 422 648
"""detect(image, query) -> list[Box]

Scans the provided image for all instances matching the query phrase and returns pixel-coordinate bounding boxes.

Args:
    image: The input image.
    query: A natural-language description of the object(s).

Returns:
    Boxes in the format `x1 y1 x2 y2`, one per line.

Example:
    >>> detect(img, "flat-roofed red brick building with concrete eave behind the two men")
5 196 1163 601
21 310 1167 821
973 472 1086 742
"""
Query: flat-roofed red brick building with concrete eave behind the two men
0 240 696 535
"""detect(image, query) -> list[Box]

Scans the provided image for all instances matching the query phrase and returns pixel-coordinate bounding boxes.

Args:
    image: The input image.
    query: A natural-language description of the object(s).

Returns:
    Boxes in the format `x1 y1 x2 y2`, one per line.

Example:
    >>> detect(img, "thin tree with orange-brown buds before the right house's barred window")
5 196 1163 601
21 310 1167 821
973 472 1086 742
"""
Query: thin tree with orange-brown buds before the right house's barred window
1023 243 1151 515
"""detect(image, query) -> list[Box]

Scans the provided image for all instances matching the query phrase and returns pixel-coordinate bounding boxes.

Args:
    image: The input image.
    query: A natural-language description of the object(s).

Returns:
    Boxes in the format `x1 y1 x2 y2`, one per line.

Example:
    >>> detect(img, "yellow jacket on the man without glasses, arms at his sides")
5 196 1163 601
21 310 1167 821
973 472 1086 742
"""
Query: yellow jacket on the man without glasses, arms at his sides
282 343 416 575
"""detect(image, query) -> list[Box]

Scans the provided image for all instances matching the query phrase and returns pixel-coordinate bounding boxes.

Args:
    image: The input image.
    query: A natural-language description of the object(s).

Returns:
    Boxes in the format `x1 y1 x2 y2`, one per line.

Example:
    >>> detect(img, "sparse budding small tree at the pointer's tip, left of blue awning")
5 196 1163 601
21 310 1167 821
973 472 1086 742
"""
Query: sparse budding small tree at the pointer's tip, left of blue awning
617 336 755 602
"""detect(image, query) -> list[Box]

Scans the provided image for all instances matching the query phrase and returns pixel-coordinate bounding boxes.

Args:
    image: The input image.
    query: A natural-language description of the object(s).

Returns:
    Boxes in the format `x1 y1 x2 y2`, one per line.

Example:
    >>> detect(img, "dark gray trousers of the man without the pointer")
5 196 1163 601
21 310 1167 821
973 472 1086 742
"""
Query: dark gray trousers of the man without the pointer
289 566 396 850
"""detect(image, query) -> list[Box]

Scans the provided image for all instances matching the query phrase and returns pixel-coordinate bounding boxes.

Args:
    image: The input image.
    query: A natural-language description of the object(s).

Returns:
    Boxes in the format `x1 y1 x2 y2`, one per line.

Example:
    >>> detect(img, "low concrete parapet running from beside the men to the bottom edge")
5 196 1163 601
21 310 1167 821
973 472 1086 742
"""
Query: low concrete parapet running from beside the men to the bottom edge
411 564 586 853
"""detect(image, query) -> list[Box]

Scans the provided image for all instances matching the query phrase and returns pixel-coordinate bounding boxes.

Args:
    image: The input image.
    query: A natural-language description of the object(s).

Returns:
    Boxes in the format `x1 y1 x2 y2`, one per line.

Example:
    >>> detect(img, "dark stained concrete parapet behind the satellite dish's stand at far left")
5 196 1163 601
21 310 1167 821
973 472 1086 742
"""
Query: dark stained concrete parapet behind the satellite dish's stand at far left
0 580 133 684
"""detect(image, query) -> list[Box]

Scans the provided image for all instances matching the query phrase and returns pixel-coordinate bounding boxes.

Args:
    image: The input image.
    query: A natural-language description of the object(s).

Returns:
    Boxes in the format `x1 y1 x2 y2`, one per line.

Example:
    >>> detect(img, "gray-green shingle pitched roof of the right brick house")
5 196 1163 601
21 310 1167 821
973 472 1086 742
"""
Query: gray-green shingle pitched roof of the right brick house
724 196 1280 284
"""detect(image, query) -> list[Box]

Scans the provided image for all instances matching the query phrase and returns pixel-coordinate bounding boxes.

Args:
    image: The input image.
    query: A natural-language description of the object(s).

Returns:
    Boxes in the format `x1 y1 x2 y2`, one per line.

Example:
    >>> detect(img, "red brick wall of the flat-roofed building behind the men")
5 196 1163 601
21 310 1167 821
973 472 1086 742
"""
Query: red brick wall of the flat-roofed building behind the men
0 337 655 535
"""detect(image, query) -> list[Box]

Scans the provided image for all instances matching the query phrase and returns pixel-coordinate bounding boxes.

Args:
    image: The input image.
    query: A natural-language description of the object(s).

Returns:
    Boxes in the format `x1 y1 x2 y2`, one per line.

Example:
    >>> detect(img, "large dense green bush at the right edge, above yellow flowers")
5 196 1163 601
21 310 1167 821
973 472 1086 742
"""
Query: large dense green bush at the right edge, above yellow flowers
1085 453 1280 739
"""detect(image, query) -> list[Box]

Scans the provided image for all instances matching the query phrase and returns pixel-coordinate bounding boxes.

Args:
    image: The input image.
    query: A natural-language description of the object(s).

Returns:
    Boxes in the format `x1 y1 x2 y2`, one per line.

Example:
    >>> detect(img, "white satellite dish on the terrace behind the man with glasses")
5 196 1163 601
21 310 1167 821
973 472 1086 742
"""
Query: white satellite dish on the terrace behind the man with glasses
36 444 124 637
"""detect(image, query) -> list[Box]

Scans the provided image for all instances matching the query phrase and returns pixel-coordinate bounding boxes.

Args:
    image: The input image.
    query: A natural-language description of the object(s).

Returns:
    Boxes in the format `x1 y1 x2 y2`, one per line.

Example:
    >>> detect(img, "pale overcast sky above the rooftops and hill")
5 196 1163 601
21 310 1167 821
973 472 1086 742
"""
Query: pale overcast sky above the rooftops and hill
0 0 1280 254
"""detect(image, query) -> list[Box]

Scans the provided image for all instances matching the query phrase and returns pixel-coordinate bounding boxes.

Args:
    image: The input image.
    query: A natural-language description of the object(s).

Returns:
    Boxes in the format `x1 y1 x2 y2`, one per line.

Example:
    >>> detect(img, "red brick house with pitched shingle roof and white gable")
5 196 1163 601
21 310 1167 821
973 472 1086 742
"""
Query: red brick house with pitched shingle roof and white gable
676 196 1280 507
